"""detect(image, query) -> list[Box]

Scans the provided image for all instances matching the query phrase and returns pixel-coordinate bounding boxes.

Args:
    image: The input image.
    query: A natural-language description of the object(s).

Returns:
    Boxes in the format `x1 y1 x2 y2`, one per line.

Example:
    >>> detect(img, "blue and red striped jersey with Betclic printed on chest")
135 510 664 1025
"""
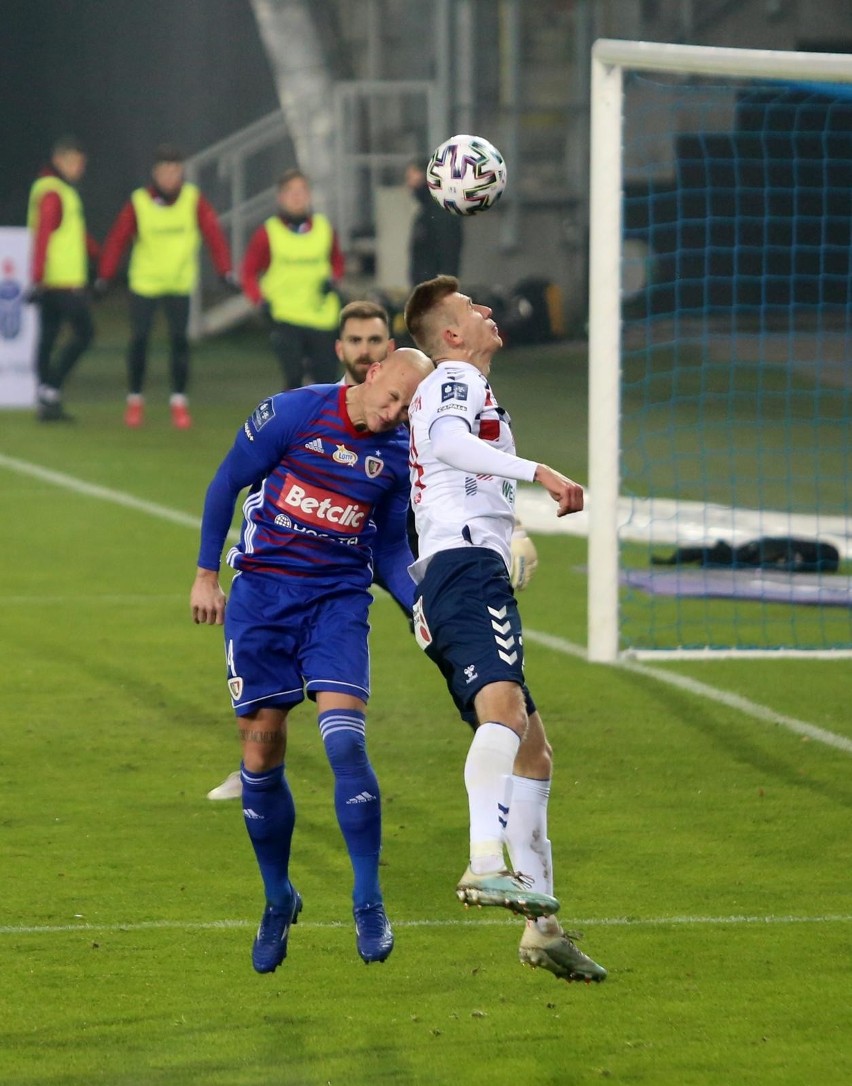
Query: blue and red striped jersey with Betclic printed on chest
199 384 414 608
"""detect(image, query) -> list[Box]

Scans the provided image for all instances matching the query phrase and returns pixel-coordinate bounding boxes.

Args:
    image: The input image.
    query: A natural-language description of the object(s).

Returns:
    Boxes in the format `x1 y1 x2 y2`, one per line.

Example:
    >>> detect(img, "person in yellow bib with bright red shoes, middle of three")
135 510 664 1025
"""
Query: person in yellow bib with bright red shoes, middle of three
96 143 232 430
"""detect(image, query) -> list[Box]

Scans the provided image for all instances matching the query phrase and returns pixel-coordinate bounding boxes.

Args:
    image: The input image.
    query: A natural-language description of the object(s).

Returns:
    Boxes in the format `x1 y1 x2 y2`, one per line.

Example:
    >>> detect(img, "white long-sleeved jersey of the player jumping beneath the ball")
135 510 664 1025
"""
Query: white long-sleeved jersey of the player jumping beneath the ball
408 362 536 582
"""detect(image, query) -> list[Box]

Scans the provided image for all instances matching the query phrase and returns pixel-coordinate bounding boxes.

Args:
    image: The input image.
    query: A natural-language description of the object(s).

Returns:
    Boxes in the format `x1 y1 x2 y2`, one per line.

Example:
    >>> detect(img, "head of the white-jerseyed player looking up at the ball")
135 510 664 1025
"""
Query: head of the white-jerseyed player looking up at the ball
405 275 503 365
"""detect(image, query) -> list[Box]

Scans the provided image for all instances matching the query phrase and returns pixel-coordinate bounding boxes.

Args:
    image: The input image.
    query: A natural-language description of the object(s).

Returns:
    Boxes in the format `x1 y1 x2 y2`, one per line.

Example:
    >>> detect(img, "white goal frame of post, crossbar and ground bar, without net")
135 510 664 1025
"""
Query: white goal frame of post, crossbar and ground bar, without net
587 38 852 664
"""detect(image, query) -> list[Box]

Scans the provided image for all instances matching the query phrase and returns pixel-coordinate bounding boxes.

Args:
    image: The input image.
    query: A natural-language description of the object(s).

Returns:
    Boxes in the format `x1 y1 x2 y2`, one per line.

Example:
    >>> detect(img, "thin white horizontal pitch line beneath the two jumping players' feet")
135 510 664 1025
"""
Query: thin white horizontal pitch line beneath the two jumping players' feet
0 913 852 935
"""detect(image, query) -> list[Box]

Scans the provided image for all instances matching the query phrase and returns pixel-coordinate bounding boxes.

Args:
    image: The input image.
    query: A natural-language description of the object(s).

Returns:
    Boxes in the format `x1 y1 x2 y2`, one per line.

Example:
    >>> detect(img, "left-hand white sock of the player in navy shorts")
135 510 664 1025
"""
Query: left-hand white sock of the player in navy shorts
465 723 521 874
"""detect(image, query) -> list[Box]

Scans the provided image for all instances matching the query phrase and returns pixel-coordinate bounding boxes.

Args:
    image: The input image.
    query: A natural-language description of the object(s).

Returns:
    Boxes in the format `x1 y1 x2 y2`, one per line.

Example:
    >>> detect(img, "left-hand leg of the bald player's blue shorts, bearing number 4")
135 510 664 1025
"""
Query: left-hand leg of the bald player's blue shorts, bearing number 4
225 573 304 714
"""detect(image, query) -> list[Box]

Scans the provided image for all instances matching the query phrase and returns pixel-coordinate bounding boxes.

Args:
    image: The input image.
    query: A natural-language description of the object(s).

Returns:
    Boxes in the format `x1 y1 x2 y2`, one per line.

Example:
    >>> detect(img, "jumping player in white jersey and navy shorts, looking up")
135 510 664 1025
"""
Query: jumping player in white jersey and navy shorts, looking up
405 276 607 981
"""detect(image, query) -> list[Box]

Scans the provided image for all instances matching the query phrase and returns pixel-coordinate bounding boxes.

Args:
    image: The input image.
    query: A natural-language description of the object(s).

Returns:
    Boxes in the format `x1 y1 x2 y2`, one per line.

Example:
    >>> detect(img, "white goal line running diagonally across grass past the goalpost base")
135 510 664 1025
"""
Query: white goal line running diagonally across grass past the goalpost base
0 453 852 754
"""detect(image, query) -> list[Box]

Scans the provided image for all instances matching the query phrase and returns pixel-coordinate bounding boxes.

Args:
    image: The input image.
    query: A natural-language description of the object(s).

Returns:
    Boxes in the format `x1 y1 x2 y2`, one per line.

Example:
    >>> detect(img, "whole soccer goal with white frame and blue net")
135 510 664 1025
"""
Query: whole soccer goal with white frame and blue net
587 40 852 662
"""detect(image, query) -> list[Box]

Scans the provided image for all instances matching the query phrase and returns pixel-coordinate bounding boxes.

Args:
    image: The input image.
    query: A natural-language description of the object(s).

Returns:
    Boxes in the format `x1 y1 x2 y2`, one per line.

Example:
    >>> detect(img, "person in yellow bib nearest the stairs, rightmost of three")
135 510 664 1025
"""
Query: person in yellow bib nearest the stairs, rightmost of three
242 169 344 389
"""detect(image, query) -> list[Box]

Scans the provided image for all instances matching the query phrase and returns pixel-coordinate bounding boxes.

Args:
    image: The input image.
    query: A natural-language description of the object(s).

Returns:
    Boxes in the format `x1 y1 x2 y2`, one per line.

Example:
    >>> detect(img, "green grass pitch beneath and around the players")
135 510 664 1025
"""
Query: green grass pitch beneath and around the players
0 310 852 1086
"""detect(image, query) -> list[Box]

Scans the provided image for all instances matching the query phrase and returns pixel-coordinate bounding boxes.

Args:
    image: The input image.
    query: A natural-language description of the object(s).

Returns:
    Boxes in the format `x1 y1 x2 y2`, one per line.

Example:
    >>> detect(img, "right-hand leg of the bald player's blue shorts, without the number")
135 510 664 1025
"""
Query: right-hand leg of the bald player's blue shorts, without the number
300 590 371 702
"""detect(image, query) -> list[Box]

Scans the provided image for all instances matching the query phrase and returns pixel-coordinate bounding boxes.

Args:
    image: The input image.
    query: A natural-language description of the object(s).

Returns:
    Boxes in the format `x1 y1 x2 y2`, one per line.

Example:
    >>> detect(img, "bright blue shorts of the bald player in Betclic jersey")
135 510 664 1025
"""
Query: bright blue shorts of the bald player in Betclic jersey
225 573 371 717
